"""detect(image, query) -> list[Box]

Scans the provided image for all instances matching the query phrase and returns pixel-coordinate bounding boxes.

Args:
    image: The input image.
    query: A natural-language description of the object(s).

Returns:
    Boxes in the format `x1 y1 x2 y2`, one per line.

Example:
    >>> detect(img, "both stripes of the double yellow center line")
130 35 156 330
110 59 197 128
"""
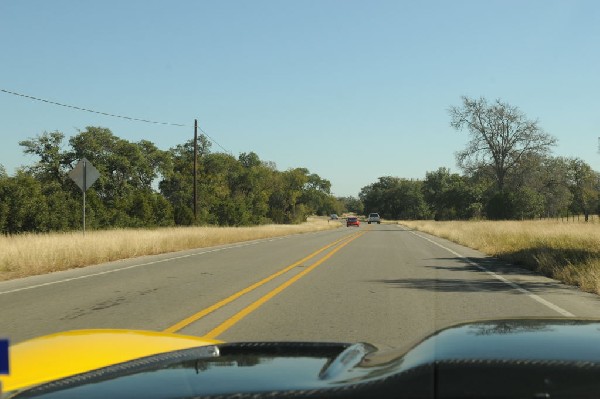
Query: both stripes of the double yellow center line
164 232 365 339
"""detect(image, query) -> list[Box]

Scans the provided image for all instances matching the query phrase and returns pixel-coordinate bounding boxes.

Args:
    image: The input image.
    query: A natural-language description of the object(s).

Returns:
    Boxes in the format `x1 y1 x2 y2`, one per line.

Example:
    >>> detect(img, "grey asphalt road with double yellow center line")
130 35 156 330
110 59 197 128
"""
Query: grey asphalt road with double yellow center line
0 224 600 348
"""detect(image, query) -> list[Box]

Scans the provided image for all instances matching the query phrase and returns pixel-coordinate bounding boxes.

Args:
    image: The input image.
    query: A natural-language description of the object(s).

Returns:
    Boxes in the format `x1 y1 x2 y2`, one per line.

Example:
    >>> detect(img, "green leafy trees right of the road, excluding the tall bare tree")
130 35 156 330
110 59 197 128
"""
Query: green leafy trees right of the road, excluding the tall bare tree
359 157 600 220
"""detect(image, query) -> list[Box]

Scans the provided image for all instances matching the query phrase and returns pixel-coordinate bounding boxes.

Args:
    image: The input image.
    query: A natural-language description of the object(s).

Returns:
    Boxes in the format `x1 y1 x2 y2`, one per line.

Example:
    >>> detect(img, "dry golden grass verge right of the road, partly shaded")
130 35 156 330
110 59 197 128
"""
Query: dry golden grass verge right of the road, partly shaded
399 221 600 294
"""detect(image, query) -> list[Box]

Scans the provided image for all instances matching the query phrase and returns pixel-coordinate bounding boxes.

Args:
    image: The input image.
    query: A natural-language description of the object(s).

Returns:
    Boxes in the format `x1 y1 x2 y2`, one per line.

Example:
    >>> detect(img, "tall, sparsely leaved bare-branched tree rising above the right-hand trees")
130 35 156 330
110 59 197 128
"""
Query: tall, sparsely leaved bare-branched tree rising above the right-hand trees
449 96 556 193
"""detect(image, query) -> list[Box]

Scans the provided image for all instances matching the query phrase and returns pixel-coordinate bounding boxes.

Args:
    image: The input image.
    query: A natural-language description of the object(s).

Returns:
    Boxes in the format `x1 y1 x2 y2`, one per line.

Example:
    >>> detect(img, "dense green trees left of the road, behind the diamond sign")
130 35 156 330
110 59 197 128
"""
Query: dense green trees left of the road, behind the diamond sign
0 127 342 234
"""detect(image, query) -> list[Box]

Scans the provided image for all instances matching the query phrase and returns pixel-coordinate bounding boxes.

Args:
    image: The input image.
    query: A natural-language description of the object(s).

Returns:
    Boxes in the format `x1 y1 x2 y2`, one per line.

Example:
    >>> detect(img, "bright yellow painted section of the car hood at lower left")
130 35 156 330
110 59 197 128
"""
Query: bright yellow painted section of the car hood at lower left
0 330 221 392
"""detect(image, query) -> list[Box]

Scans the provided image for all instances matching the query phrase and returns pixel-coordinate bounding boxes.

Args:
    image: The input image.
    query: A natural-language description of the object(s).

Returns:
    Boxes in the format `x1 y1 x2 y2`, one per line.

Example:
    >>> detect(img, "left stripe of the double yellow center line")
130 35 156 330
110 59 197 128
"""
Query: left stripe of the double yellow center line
163 232 364 333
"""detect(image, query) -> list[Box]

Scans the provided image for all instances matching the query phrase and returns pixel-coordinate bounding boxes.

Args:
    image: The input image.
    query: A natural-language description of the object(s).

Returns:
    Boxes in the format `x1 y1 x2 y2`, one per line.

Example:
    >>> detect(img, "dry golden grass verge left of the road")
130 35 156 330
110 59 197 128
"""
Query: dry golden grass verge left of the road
0 218 341 280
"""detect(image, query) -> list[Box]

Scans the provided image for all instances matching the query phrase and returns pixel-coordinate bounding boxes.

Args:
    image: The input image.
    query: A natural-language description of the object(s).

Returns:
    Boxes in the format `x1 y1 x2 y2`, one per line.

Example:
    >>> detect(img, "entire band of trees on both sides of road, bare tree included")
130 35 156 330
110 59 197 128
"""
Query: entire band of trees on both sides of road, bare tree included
0 97 600 234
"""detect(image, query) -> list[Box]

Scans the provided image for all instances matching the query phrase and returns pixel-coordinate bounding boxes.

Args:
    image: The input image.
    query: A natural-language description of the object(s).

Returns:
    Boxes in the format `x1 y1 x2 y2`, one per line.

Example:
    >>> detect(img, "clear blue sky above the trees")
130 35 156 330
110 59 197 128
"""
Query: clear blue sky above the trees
0 0 600 195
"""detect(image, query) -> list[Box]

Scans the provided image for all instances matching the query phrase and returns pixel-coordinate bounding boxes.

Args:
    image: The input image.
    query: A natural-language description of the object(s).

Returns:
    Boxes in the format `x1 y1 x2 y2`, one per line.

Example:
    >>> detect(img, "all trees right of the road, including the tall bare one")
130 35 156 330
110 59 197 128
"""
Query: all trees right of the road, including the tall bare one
359 97 600 220
